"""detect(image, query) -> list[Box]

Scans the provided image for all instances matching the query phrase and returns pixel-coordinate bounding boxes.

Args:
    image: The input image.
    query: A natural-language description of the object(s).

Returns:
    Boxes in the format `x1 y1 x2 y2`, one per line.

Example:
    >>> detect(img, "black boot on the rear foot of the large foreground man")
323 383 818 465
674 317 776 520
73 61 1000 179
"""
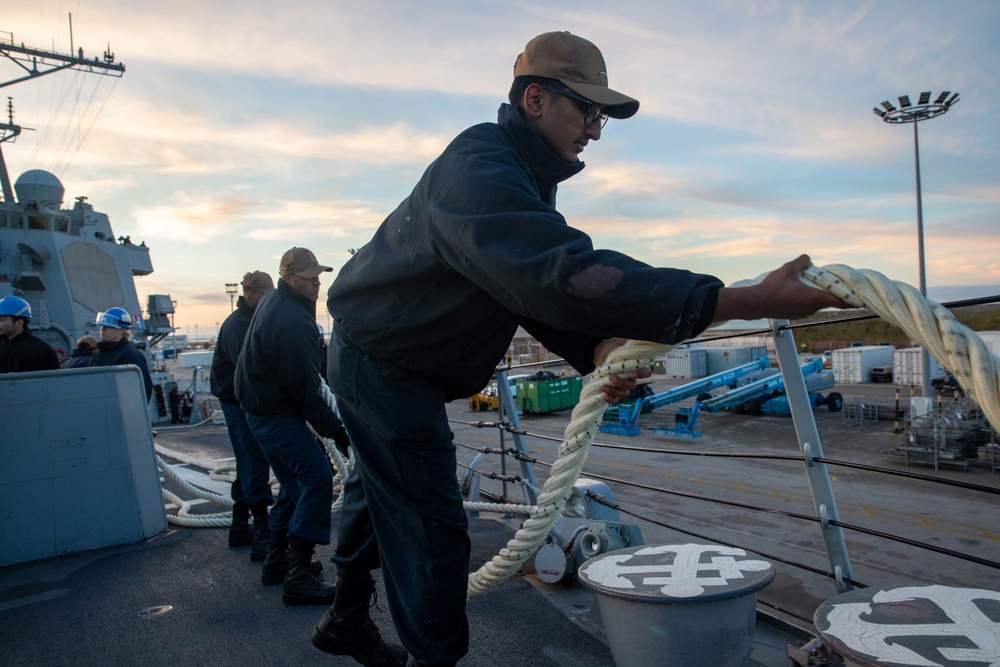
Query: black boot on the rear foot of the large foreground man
312 571 407 667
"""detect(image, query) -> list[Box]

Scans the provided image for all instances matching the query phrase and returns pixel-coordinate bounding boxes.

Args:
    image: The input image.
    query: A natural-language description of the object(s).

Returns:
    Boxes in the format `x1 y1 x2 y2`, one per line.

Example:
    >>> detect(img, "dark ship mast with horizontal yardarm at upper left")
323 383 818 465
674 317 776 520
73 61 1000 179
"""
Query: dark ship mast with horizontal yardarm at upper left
0 14 125 202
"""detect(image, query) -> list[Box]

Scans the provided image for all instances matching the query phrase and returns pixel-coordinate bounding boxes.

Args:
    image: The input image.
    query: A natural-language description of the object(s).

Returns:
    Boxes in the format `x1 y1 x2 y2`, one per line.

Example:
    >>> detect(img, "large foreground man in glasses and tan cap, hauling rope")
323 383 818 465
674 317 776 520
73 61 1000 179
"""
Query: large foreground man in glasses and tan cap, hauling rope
313 32 842 667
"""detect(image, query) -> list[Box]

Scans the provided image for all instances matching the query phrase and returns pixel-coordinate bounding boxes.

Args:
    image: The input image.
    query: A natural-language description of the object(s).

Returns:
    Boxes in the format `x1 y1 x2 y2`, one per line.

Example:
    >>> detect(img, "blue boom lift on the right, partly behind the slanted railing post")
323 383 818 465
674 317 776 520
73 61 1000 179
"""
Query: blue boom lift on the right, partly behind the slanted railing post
653 359 844 438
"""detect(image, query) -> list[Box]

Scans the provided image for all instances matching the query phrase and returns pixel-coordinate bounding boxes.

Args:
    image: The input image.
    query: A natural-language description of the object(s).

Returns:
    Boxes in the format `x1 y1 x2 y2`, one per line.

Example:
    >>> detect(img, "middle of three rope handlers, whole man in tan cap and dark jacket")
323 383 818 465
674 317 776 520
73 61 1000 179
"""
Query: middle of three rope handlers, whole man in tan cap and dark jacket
235 248 348 604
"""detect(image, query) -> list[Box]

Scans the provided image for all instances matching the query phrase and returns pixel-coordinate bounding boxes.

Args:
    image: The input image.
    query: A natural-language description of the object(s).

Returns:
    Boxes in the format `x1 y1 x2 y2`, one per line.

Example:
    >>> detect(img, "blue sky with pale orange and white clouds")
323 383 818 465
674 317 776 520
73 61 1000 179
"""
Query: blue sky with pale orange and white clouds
0 0 1000 333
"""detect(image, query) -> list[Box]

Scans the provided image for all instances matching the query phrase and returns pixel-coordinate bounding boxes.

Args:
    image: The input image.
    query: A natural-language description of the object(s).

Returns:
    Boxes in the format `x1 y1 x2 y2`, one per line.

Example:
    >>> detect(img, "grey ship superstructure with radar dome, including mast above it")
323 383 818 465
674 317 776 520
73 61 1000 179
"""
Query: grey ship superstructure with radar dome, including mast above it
0 28 173 421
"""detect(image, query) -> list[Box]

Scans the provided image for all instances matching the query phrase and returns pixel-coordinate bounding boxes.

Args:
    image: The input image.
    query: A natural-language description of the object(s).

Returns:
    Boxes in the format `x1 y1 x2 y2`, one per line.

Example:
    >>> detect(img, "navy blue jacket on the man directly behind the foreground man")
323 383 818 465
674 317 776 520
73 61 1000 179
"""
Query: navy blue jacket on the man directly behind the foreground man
235 279 344 439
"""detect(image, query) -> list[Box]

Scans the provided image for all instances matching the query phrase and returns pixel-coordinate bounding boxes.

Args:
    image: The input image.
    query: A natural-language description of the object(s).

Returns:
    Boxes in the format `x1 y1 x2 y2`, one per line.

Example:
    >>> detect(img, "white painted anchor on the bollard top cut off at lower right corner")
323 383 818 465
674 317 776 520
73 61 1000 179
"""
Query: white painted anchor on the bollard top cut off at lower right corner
824 586 1000 667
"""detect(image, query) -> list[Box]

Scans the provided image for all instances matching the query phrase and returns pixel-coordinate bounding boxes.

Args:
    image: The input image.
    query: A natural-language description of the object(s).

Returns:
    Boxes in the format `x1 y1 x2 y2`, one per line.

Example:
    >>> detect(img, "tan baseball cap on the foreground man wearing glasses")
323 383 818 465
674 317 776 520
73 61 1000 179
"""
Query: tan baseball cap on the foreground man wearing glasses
514 32 639 118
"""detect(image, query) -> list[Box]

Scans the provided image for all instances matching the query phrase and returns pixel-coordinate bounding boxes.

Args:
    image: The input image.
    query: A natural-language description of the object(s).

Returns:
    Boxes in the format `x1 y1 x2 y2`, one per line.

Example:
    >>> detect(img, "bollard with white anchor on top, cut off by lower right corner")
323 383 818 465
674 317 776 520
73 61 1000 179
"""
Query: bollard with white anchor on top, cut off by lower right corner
813 586 1000 667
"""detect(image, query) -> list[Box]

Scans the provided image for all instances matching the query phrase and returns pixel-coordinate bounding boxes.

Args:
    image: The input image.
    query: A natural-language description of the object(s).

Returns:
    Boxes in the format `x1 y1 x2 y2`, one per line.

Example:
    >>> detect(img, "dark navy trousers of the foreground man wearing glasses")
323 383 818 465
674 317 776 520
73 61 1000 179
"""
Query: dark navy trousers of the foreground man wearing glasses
329 336 470 666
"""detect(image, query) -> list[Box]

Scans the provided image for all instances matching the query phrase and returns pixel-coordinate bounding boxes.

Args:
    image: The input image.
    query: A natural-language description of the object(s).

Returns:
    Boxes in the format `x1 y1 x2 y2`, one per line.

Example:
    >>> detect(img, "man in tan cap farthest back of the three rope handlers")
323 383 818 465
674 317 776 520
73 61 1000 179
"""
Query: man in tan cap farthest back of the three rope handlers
211 271 274 570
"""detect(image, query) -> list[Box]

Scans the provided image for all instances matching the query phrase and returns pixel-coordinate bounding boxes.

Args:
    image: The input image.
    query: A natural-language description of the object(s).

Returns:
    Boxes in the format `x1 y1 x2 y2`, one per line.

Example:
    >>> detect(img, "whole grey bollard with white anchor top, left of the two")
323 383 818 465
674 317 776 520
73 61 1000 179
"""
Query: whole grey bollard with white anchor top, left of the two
578 544 774 667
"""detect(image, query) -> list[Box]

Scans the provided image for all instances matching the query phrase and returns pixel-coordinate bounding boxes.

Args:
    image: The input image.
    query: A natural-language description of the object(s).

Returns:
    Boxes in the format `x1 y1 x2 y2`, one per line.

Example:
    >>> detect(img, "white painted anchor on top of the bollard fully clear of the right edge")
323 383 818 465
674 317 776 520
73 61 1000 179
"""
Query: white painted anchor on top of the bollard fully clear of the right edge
587 544 771 598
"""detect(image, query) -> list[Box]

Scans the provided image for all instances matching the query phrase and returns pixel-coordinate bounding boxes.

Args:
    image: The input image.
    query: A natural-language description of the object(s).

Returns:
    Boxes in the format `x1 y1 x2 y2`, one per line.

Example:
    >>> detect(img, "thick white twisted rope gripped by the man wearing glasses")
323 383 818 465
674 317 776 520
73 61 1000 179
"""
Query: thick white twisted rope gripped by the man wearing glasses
468 264 1000 596
